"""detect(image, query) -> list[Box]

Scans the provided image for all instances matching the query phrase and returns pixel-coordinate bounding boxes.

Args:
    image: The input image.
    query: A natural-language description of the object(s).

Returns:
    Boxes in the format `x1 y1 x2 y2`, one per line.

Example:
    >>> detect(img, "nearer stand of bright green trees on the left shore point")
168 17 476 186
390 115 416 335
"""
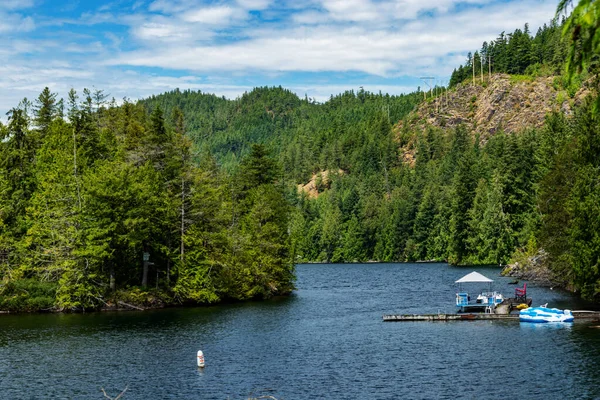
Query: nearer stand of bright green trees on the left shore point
0 88 294 311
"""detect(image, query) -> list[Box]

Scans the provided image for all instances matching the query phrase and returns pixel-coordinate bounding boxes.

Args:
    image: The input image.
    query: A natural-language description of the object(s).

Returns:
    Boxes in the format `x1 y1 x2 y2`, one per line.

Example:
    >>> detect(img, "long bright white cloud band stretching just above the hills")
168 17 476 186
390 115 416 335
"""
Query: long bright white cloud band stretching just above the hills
108 0 554 77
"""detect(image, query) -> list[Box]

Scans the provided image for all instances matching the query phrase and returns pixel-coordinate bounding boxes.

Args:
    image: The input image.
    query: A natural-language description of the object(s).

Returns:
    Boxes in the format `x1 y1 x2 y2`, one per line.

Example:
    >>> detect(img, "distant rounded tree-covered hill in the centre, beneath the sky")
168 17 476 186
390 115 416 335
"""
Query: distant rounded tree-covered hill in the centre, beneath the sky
141 87 422 177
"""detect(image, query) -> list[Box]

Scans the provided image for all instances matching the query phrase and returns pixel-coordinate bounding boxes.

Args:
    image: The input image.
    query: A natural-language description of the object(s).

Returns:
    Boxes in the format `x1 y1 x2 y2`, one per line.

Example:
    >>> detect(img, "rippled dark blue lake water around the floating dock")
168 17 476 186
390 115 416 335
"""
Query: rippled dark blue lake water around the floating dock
0 264 600 400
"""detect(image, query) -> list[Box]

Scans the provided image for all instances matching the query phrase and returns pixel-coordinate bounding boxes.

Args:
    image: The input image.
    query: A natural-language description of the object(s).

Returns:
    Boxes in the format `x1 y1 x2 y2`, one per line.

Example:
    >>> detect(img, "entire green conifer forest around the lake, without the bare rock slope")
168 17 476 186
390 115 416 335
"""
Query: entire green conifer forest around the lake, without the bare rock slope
0 3 600 310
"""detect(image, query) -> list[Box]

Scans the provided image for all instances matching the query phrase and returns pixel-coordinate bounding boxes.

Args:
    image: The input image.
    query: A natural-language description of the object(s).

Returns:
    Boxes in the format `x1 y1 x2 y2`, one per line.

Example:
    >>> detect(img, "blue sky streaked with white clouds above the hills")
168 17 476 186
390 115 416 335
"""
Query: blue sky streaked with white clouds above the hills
0 0 557 115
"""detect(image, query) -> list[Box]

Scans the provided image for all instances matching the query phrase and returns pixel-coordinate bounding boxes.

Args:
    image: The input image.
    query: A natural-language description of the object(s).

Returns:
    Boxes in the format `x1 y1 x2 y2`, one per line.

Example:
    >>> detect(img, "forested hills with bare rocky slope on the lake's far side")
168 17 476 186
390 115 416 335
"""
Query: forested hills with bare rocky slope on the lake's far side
139 12 600 297
